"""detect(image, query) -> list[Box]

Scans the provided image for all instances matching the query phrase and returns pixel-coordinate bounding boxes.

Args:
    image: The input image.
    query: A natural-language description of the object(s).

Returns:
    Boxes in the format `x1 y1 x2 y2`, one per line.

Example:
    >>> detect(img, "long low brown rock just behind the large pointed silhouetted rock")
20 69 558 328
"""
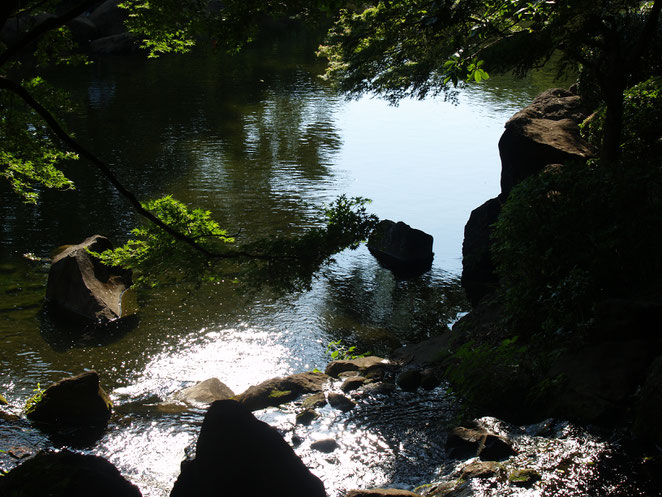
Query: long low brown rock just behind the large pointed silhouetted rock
236 372 329 411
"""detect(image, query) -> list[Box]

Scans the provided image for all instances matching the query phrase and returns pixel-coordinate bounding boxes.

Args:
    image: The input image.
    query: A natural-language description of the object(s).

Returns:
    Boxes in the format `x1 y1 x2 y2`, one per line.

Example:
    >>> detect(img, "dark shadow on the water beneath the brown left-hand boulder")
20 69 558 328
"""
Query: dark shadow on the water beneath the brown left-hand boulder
39 302 140 352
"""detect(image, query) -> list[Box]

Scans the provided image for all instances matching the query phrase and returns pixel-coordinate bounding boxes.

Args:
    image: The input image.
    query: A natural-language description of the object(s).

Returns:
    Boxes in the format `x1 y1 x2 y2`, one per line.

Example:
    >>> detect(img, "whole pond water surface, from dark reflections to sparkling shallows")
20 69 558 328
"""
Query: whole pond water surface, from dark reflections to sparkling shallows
0 29 648 497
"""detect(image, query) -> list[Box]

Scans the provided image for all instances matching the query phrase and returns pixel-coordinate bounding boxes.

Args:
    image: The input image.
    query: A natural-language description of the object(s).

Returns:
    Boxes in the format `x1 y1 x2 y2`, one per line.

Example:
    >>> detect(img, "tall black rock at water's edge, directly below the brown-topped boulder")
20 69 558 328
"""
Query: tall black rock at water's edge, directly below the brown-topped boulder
461 195 504 306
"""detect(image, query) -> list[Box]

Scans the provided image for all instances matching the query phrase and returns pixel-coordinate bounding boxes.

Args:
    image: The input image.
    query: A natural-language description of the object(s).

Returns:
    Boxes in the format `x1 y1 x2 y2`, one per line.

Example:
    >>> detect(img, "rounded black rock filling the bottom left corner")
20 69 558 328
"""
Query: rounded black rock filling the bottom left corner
0 450 142 497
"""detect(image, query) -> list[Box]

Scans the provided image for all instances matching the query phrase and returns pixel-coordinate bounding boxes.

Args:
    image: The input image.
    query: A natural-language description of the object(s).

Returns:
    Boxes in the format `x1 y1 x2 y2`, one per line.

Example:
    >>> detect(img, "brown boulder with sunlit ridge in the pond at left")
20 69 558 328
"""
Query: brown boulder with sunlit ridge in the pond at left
46 235 131 322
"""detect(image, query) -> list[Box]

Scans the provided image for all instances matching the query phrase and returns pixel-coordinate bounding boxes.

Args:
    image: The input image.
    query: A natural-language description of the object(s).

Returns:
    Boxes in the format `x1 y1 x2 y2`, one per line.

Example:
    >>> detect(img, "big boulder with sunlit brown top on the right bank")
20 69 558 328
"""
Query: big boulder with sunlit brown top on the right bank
499 88 594 194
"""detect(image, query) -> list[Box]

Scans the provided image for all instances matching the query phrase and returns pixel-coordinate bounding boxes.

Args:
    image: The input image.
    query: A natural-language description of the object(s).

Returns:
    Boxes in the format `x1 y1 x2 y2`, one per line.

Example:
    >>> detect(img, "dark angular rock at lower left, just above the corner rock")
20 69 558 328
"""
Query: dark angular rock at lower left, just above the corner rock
26 371 112 427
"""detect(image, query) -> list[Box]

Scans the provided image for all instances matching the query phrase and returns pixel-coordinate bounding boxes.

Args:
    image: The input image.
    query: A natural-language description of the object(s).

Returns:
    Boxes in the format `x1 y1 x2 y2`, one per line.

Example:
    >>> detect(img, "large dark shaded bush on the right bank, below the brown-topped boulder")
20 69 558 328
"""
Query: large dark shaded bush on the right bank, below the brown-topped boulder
493 147 662 335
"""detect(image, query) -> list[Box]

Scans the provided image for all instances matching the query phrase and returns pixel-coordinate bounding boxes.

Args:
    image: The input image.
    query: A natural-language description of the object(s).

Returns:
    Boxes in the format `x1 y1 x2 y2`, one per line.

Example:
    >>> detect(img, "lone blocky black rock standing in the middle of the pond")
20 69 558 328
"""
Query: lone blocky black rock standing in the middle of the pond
368 219 434 275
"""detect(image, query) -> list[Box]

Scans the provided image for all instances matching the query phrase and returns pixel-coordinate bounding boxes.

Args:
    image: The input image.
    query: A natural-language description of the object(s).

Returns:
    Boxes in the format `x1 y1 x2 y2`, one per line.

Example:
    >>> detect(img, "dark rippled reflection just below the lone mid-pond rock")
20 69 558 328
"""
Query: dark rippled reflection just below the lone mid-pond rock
324 259 467 353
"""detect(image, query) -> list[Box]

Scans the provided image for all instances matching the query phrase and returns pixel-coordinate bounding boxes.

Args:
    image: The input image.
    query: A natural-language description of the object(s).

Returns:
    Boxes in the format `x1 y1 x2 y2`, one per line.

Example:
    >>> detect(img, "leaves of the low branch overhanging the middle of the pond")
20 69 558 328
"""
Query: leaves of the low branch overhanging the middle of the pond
94 195 377 290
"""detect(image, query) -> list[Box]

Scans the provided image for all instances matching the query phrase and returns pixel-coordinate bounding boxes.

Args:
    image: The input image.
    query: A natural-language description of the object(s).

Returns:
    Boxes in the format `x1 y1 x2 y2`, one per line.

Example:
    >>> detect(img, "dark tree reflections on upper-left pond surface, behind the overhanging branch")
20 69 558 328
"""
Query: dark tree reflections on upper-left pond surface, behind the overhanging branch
0 28 340 255
